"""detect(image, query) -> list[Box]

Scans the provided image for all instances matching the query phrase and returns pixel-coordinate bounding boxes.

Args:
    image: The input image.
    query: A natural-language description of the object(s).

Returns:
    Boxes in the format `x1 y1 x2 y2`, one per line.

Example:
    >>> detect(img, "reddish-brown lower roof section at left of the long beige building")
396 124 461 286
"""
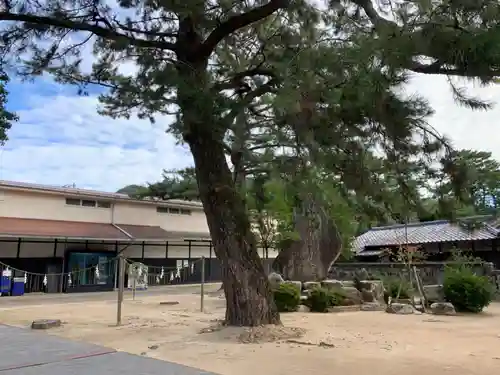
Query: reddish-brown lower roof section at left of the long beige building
0 217 129 241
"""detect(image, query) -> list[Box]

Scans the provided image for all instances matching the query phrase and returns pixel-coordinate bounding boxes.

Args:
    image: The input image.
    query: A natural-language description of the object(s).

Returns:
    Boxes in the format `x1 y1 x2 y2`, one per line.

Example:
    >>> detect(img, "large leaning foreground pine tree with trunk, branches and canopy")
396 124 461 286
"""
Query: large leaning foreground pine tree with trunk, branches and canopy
0 0 500 325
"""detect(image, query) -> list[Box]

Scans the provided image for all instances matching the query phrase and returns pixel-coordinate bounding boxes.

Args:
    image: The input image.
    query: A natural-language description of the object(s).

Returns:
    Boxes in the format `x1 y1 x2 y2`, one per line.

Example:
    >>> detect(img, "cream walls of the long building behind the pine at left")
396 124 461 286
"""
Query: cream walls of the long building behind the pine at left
0 189 277 259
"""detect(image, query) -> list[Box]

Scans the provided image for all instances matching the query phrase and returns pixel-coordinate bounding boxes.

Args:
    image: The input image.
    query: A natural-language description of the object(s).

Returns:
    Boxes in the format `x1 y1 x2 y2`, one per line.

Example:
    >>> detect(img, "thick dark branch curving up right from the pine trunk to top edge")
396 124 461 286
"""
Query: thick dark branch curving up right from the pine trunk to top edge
202 0 290 57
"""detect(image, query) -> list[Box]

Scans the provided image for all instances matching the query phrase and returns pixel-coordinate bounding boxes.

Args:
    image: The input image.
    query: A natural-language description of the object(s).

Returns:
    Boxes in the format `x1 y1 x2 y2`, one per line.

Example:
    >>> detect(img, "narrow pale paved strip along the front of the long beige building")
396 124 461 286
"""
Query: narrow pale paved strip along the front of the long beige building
0 283 220 309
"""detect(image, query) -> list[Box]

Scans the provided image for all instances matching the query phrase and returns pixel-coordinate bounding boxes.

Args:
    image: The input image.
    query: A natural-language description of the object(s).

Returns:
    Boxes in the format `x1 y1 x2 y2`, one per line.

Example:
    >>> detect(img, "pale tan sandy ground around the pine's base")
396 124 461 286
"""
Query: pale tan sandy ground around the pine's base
0 294 500 375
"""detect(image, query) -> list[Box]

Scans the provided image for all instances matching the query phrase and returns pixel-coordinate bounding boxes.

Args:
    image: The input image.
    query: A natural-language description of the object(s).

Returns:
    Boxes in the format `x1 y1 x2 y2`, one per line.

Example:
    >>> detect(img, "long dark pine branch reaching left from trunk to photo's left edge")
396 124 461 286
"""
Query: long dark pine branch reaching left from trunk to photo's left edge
0 12 175 51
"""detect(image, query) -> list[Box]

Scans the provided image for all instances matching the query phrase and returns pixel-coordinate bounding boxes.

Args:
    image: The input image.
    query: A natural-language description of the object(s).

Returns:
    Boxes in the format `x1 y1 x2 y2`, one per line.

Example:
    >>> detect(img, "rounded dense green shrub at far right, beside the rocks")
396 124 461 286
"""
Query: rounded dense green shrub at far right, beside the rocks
443 267 493 313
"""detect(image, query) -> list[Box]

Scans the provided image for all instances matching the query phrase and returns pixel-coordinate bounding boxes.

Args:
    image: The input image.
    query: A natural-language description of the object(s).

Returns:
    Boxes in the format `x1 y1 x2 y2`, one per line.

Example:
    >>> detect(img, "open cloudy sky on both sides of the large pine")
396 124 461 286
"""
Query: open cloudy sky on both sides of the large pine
0 72 500 191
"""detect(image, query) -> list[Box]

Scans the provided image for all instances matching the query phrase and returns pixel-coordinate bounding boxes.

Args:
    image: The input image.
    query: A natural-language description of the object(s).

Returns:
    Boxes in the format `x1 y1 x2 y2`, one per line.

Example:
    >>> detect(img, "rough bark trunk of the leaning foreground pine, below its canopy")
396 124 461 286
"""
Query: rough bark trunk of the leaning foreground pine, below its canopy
186 127 280 326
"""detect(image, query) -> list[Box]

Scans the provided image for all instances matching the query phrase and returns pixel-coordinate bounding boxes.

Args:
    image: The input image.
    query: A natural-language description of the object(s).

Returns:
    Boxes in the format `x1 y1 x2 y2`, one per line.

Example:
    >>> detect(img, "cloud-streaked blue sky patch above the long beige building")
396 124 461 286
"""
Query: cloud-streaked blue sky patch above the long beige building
0 91 192 191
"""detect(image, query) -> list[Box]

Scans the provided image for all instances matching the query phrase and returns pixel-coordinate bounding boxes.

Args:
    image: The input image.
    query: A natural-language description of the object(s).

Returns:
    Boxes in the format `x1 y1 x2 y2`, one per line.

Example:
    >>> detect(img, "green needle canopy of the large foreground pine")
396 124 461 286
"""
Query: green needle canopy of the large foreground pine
0 0 488 232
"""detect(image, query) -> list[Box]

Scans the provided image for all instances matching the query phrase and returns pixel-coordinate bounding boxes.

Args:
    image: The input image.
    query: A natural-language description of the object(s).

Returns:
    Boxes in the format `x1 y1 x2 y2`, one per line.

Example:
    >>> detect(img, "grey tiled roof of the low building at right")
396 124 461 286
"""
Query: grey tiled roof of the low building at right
353 220 500 255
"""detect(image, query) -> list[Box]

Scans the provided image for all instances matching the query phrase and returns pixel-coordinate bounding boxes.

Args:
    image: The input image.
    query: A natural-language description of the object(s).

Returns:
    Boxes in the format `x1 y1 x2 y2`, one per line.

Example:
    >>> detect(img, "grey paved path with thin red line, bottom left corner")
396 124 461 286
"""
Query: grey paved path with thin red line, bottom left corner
0 325 216 375
